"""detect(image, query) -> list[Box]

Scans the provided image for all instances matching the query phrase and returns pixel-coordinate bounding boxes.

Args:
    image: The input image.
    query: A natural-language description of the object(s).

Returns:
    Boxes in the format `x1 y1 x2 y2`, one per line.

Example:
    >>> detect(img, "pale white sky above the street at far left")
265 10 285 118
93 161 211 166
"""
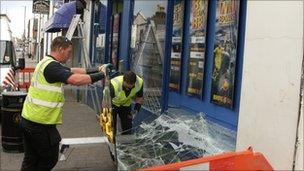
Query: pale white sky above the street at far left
0 0 34 38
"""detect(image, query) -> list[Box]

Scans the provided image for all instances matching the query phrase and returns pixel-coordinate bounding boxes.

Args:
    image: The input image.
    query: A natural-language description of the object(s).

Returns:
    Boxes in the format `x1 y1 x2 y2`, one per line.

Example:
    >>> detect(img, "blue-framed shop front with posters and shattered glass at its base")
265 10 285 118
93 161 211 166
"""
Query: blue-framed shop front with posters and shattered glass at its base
100 0 246 169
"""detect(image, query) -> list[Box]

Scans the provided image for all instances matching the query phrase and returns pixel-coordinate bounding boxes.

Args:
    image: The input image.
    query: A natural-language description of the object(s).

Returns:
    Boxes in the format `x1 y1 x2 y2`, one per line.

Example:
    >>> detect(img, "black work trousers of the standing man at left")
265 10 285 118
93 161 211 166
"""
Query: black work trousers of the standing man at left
20 118 61 171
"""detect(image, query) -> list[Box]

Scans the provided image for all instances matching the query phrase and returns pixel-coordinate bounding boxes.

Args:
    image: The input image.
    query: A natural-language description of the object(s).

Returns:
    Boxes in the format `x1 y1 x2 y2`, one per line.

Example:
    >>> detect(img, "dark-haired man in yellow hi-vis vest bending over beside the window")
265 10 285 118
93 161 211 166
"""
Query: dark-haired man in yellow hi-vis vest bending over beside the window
110 71 144 134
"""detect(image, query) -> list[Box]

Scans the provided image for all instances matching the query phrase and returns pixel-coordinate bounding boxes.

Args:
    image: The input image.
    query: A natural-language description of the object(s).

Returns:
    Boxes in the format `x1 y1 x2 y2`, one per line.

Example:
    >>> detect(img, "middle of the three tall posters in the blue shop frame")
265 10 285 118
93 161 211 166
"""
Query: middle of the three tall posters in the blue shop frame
187 0 208 98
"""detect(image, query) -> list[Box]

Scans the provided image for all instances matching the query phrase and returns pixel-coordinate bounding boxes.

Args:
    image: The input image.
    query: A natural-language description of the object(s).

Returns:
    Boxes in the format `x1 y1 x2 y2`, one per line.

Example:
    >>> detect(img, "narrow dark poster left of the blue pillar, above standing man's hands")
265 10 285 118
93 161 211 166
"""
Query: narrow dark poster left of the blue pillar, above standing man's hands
111 14 120 69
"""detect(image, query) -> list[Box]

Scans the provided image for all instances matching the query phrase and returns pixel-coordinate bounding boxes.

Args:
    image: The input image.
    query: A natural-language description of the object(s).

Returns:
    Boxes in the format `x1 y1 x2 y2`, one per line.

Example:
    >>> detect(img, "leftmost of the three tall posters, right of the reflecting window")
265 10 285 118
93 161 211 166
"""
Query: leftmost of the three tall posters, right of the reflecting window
169 0 184 91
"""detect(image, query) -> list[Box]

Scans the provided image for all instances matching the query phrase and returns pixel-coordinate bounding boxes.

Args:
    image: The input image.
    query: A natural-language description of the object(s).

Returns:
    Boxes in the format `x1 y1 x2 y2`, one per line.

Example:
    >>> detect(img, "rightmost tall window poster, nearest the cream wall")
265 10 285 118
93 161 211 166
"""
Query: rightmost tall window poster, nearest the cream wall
211 0 240 108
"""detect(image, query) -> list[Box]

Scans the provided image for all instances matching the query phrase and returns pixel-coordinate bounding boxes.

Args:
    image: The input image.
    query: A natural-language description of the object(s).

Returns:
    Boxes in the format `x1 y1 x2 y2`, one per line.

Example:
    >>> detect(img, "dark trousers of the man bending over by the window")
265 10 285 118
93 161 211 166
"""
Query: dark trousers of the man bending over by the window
113 105 133 134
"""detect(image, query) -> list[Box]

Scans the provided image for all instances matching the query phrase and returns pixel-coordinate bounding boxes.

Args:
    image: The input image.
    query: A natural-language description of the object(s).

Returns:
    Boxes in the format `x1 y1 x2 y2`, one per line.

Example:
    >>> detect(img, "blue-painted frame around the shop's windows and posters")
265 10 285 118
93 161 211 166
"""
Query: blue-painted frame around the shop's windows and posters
105 0 247 130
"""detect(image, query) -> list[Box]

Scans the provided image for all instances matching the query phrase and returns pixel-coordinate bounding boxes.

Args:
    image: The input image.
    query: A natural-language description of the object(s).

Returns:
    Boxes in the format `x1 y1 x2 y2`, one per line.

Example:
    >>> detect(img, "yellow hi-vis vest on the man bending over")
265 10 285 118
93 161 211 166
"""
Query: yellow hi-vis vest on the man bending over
111 76 143 106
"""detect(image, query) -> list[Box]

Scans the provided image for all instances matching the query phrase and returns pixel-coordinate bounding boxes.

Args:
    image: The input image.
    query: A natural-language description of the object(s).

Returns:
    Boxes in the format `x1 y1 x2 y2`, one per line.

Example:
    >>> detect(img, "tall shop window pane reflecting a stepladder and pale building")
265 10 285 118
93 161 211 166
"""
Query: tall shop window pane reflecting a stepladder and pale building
130 0 167 112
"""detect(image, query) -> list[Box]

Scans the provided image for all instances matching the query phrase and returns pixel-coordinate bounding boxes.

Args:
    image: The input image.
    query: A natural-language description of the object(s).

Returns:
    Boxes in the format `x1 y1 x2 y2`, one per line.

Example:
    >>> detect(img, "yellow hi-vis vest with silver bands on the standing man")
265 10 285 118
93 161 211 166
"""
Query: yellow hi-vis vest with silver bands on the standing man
22 57 64 124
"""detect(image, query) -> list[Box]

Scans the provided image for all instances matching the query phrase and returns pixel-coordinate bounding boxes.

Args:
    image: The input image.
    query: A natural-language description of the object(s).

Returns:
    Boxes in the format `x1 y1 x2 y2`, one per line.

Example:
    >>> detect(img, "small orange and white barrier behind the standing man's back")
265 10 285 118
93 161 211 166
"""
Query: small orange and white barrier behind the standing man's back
18 68 35 90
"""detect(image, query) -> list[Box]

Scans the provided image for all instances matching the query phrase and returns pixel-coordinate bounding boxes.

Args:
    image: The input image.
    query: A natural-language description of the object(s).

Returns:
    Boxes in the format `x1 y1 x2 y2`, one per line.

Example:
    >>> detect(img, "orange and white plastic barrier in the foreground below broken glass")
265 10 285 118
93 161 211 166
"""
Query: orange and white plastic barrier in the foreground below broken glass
139 147 273 171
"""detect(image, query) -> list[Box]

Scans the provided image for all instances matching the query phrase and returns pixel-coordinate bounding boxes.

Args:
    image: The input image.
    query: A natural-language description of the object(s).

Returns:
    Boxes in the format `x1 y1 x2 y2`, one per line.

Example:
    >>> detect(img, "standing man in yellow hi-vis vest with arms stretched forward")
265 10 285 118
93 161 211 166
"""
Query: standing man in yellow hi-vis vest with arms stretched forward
20 36 105 170
